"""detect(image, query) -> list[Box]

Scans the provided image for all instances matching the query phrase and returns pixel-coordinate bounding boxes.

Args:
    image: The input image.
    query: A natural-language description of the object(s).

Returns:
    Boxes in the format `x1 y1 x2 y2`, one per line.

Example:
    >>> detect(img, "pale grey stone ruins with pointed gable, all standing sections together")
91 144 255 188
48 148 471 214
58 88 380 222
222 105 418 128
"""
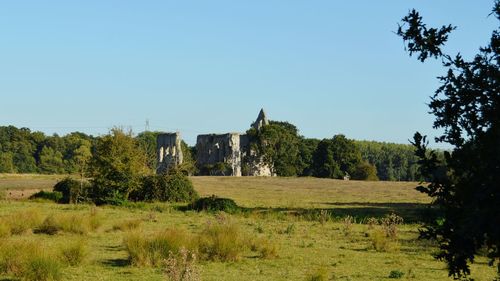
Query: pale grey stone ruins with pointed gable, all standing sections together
157 109 273 176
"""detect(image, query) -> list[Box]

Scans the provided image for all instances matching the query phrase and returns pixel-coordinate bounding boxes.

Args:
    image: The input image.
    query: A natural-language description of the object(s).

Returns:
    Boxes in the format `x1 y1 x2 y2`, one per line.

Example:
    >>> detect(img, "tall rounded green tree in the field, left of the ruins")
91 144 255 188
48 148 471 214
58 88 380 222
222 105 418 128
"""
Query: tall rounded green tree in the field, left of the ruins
89 128 147 204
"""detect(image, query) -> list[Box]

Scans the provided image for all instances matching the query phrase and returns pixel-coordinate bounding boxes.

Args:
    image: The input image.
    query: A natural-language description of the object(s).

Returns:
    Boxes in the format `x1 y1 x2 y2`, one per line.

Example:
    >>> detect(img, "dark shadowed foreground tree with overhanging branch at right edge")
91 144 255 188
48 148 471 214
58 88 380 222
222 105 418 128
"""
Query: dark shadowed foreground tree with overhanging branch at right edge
397 1 500 278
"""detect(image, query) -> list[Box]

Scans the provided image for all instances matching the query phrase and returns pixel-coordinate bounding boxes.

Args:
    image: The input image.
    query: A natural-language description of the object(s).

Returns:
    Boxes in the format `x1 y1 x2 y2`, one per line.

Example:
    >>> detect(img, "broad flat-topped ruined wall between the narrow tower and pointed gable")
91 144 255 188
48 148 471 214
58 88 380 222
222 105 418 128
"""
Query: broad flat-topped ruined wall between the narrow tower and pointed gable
196 133 241 176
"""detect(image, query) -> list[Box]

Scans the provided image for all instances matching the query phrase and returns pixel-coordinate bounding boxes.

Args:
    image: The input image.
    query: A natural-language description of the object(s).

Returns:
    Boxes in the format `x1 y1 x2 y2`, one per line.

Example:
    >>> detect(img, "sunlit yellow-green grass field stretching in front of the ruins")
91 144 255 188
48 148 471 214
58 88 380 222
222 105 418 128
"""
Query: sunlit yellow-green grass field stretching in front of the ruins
0 175 495 280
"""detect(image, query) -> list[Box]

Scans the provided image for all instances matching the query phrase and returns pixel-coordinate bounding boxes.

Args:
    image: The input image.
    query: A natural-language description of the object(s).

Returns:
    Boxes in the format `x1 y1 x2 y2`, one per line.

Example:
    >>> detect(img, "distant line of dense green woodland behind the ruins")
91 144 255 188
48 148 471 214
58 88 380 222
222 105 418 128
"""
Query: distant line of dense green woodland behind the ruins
0 121 421 181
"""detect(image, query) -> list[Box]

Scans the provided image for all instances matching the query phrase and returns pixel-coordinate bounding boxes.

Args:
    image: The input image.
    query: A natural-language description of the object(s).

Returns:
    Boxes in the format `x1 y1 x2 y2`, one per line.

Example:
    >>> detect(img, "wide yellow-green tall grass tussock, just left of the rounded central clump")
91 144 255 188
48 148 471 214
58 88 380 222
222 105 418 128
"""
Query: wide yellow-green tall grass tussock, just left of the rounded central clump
123 229 193 266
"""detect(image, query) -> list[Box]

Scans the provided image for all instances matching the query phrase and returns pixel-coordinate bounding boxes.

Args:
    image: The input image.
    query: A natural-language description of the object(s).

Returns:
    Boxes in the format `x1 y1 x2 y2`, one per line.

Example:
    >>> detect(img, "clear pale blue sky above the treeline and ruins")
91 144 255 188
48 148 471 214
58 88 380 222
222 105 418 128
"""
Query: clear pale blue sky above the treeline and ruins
0 0 497 147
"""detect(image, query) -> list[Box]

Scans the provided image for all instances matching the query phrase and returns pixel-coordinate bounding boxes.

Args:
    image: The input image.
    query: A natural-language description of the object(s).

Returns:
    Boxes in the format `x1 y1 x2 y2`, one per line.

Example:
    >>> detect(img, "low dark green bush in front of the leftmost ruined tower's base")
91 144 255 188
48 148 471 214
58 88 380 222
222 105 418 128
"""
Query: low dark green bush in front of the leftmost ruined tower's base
130 170 198 202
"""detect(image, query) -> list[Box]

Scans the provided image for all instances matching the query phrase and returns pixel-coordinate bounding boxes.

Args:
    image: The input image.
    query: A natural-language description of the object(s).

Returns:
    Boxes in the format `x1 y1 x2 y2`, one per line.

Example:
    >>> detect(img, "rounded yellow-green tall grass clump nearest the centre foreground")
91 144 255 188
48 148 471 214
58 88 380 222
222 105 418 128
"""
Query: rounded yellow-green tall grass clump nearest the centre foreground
198 220 248 261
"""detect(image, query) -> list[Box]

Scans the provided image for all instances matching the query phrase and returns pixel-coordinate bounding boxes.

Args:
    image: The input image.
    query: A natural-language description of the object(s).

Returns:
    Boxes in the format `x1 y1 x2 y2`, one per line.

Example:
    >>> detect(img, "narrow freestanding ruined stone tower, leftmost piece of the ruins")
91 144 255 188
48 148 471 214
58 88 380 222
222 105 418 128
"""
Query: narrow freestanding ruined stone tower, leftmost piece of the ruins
156 132 183 173
